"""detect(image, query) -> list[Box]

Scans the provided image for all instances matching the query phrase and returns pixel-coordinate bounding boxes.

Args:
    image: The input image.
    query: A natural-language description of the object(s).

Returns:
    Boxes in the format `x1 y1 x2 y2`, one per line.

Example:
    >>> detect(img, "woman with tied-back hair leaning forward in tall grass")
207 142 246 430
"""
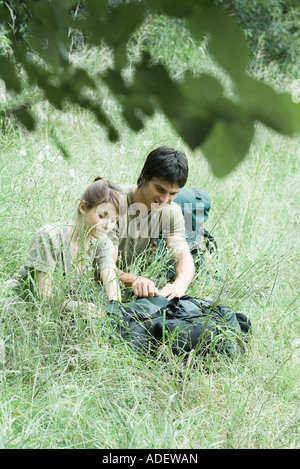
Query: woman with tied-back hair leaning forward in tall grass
10 178 126 316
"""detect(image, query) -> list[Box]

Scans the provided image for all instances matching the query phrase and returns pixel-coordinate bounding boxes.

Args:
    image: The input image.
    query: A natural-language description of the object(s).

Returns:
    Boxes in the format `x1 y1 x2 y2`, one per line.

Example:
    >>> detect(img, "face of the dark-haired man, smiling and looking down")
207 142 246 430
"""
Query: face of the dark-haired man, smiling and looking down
141 177 180 210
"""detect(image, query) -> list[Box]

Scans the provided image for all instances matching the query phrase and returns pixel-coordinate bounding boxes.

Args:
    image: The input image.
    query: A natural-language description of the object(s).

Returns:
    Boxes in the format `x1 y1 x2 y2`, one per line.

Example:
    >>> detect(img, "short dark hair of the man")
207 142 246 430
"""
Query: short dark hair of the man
137 146 189 187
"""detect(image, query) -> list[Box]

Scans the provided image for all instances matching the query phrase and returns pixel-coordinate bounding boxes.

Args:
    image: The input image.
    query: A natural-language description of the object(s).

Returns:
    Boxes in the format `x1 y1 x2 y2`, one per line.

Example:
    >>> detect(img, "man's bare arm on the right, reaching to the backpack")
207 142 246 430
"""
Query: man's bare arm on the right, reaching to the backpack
159 236 195 300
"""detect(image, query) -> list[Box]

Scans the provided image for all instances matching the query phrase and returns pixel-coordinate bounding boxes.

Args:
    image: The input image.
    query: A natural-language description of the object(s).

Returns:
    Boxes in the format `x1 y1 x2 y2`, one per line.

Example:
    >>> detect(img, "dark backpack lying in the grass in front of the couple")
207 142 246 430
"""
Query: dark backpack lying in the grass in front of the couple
107 295 252 356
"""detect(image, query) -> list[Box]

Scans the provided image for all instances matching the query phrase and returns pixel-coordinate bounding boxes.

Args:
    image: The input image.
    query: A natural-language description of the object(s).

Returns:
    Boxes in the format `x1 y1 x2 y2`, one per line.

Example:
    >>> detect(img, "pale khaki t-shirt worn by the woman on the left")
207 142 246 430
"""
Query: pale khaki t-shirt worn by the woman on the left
7 223 116 294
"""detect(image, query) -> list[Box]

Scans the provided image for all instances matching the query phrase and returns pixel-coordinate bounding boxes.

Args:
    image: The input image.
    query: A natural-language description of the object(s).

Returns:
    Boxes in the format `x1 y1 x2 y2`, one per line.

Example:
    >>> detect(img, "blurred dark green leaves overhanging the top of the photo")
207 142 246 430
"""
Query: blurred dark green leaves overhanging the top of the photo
0 0 300 176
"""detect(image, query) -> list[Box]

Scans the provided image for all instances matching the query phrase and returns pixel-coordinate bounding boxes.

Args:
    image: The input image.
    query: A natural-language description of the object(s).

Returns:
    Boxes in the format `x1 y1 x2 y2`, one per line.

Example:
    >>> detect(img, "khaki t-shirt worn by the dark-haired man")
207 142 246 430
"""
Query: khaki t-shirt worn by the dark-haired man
108 185 185 269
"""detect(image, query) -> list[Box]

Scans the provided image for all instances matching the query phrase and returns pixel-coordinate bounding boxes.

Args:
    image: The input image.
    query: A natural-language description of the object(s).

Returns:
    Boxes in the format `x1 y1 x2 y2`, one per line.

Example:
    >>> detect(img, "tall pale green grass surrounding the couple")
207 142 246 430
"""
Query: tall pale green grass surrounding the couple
0 42 300 449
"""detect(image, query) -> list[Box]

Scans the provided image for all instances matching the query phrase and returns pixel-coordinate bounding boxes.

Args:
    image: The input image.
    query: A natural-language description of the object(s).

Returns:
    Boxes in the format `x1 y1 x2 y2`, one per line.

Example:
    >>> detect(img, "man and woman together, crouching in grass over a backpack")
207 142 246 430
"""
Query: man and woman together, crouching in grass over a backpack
11 147 195 316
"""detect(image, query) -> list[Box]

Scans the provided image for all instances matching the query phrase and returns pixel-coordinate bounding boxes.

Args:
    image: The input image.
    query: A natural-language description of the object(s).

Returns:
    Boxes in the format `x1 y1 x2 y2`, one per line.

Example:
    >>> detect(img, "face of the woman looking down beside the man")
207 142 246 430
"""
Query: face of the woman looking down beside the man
80 202 118 238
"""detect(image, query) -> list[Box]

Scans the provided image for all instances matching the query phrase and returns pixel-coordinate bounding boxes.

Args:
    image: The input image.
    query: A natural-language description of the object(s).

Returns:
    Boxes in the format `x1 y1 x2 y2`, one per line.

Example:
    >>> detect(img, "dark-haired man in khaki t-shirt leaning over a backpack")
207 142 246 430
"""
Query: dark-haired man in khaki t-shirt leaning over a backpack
112 147 195 300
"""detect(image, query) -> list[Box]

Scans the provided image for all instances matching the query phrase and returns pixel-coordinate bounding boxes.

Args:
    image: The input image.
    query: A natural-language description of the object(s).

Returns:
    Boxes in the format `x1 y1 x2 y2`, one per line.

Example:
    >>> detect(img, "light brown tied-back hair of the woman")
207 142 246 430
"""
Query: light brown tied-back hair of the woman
77 176 127 216
